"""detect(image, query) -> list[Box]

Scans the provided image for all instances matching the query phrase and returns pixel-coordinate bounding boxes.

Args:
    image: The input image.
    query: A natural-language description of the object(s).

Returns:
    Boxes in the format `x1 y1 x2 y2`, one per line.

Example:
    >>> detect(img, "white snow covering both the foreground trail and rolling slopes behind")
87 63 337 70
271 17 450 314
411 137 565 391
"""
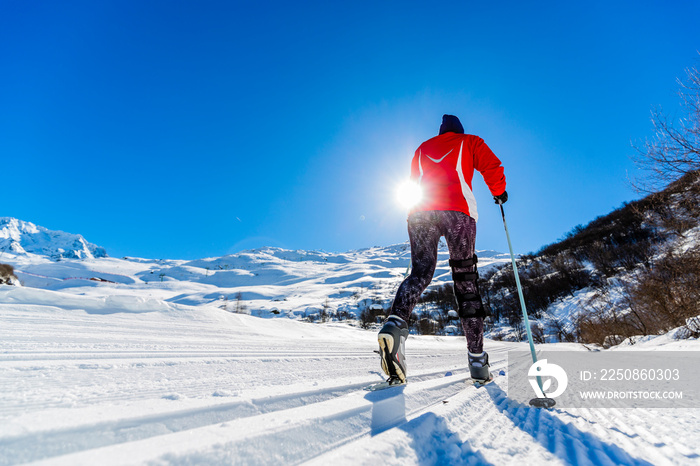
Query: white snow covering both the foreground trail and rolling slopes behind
0 220 700 465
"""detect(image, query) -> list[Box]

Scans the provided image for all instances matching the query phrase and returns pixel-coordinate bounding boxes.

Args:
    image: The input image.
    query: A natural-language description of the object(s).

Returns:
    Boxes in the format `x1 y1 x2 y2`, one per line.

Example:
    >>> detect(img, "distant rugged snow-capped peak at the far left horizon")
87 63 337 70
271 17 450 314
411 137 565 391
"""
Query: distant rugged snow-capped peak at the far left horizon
0 217 107 260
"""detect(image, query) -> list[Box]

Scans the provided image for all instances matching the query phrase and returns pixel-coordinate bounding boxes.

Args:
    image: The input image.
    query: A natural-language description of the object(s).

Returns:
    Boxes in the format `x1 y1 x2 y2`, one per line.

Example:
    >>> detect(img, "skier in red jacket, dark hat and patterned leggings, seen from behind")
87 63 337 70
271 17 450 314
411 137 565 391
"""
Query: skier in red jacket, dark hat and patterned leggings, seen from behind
378 115 508 385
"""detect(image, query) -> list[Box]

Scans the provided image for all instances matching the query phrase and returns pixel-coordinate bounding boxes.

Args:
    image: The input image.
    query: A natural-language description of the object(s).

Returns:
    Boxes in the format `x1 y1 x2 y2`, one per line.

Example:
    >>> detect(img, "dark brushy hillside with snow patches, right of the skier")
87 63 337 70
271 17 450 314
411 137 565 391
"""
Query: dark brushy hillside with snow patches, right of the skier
482 171 700 346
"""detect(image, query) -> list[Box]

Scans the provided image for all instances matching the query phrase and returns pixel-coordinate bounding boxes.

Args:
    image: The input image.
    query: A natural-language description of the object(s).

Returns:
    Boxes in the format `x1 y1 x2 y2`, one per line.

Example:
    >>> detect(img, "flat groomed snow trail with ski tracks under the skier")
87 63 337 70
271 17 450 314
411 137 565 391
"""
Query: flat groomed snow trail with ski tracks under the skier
0 304 700 465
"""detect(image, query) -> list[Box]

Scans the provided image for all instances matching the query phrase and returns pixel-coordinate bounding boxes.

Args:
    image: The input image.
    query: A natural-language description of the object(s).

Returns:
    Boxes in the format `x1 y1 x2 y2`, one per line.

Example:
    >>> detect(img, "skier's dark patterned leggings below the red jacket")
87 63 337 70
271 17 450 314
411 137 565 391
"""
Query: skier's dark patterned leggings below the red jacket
391 210 484 354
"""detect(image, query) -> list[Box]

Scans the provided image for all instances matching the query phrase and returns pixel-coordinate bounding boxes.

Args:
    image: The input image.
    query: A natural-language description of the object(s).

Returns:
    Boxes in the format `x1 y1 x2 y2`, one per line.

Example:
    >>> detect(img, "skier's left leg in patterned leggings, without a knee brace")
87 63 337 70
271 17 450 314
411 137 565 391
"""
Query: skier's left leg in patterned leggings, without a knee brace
391 211 442 323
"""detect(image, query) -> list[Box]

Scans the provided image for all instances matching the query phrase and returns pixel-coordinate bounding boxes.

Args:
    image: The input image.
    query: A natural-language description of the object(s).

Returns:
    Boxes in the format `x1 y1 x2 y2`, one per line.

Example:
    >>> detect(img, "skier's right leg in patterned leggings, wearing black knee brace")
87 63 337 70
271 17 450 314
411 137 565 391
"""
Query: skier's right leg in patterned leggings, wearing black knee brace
442 211 485 354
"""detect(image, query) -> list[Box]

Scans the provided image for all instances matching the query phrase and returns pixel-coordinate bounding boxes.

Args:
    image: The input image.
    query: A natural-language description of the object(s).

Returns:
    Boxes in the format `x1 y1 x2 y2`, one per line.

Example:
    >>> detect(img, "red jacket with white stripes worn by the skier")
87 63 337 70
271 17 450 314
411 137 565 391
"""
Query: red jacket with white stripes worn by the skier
411 132 506 220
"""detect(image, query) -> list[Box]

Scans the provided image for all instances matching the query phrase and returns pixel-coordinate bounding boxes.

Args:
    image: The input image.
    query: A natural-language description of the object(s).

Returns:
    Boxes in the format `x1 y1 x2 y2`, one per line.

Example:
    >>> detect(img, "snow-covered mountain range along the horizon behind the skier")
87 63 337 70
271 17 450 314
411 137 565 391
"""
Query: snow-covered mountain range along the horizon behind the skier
0 219 510 319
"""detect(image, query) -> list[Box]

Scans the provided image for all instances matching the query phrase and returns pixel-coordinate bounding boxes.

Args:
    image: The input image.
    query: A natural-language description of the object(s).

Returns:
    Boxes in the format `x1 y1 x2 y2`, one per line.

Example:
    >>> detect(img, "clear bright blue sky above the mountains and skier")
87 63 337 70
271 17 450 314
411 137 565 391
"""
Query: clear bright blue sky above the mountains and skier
0 0 700 259
